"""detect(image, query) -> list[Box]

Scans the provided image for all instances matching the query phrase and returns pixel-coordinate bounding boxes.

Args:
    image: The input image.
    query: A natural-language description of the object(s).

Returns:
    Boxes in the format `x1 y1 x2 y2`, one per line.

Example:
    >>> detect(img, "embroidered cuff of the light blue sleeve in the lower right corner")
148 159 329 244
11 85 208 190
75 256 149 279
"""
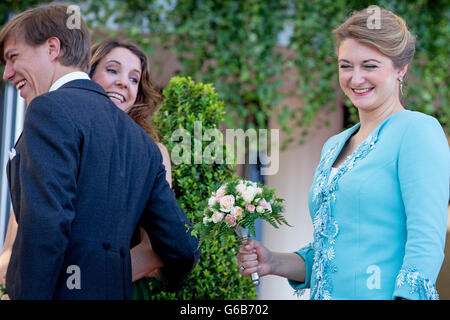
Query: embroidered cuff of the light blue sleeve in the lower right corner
393 267 439 300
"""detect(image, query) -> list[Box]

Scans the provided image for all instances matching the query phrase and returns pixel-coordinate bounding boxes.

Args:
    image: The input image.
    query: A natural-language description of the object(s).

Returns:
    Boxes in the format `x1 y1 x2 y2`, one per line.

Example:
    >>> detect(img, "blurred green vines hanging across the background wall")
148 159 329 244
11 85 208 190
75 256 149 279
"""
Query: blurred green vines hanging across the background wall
0 0 450 145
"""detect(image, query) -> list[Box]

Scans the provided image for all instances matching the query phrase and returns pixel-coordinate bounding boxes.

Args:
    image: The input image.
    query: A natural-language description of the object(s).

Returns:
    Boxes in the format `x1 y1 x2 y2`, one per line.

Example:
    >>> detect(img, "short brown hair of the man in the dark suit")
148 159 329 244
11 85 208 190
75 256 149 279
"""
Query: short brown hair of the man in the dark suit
0 5 91 72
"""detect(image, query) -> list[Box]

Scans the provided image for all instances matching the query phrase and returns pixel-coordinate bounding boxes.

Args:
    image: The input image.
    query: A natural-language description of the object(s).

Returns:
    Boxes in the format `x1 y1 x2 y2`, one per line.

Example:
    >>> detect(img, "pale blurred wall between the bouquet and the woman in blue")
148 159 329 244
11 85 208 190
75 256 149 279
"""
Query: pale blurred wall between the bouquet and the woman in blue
259 99 343 300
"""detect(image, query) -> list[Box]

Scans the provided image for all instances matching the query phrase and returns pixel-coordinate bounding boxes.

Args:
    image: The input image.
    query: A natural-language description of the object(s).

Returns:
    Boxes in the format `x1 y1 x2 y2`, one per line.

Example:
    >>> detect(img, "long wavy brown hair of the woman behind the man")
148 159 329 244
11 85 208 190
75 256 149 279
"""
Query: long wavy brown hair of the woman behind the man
89 38 161 141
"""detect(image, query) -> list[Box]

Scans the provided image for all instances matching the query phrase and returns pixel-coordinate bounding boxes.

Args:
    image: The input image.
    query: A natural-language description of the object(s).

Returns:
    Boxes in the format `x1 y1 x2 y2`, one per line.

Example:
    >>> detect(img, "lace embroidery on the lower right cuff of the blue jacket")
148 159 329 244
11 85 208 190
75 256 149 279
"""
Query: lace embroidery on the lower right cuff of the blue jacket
396 267 439 300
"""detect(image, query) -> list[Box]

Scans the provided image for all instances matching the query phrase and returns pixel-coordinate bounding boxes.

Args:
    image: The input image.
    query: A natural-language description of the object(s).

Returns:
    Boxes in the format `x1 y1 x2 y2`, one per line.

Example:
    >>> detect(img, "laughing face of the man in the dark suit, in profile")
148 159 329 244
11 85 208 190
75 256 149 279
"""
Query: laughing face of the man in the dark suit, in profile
3 36 54 105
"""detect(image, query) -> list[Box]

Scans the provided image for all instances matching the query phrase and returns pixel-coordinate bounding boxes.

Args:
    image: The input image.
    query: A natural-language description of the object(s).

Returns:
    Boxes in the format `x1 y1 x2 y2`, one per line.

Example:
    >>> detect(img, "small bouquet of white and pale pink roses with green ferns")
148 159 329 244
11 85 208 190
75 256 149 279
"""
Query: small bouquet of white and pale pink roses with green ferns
191 179 290 285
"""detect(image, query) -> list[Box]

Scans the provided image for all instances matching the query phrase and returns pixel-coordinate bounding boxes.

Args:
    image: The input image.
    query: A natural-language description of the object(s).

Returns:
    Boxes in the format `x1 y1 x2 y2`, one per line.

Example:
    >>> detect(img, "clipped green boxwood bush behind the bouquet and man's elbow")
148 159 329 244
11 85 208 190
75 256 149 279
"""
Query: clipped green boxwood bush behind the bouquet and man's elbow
149 77 257 300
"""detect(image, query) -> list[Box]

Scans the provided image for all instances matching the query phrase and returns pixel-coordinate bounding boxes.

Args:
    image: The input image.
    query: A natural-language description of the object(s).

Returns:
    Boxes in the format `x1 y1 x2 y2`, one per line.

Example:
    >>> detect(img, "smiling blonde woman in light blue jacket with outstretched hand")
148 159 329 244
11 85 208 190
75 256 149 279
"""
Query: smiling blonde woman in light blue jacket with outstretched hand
238 8 450 299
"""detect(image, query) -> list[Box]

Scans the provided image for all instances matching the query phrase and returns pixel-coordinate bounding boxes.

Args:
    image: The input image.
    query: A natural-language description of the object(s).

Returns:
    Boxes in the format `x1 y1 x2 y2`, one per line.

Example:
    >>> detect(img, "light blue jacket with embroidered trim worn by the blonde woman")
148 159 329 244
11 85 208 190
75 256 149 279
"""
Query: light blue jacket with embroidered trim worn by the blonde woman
289 110 450 299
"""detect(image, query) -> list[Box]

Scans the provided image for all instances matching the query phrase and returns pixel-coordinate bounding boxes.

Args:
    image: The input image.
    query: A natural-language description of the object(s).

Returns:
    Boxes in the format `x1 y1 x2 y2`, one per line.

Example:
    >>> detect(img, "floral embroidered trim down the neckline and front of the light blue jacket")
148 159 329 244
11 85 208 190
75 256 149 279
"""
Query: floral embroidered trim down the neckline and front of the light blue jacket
310 135 377 300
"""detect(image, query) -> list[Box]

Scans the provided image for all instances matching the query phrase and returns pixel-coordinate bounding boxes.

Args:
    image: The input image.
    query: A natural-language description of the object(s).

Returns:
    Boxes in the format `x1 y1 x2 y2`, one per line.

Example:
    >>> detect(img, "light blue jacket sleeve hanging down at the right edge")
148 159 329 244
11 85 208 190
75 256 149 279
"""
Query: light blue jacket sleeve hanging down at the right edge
393 116 450 300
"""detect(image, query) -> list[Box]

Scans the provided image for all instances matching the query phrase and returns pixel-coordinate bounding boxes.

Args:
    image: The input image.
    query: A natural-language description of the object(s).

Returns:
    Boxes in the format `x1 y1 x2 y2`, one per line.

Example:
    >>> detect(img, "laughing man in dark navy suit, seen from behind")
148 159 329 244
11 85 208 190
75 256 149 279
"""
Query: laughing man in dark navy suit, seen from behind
0 5 200 299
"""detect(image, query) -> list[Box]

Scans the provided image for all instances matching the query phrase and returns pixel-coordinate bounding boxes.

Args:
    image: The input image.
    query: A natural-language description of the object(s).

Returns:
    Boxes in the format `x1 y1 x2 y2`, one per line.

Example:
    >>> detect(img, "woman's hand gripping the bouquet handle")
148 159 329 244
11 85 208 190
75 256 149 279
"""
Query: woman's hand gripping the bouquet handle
237 240 274 277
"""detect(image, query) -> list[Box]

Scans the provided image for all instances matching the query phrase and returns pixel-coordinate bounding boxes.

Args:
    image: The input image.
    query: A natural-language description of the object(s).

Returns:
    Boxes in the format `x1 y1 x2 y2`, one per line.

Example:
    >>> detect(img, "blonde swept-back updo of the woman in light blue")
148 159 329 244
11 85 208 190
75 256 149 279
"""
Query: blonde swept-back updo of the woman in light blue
333 6 415 68
